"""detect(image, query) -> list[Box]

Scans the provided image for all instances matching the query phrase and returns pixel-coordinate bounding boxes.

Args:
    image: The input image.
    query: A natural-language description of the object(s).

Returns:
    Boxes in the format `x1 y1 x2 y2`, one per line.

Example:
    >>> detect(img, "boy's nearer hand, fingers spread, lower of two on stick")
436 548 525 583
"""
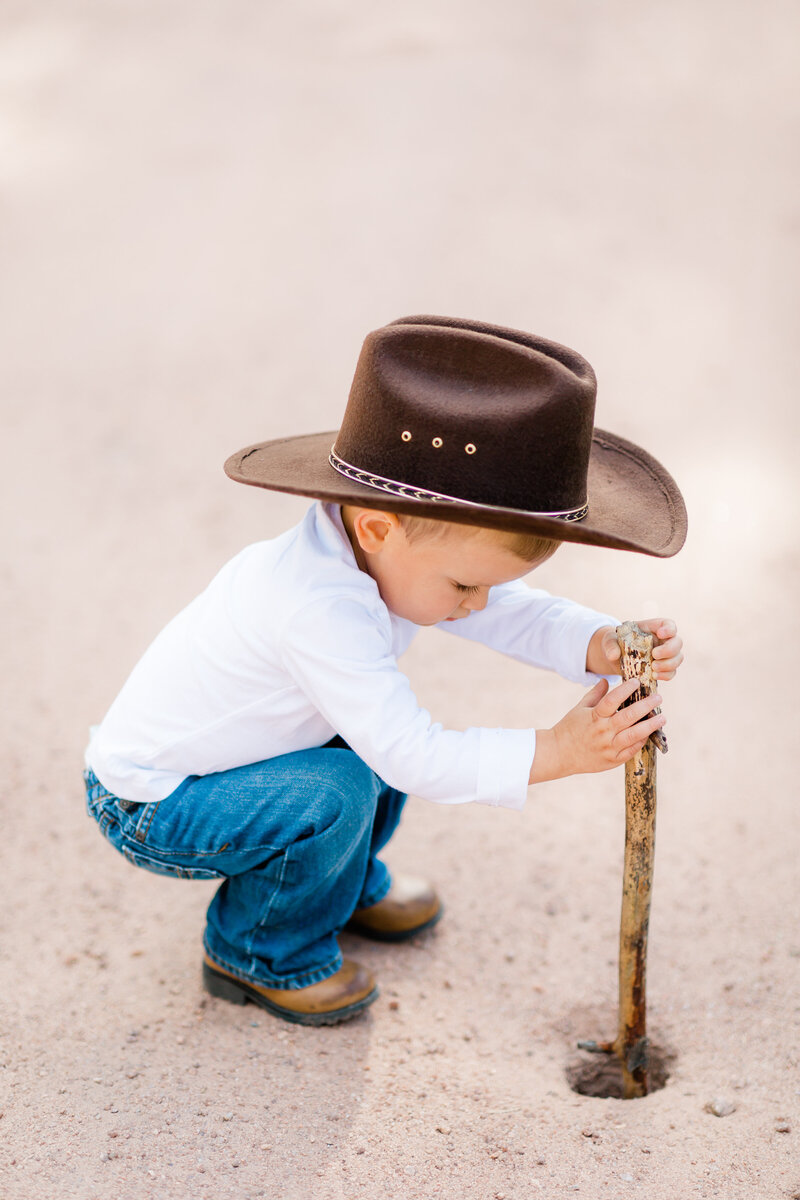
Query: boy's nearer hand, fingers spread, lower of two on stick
529 679 667 784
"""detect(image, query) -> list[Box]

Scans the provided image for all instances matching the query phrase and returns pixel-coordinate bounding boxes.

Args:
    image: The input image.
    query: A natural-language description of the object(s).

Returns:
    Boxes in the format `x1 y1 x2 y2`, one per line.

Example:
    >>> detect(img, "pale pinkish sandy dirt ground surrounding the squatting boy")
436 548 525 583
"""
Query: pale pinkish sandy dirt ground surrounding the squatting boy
0 0 800 1200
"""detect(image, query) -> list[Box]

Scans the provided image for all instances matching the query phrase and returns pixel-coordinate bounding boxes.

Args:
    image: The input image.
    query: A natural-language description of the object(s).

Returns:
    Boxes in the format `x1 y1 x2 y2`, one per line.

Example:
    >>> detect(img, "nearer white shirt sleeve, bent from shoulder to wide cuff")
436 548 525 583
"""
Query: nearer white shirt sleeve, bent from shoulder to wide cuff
281 596 536 809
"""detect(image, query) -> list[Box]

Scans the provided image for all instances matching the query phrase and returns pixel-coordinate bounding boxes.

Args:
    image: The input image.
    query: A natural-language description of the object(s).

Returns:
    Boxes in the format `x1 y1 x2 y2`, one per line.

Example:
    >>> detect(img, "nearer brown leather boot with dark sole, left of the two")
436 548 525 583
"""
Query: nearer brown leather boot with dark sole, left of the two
203 955 379 1025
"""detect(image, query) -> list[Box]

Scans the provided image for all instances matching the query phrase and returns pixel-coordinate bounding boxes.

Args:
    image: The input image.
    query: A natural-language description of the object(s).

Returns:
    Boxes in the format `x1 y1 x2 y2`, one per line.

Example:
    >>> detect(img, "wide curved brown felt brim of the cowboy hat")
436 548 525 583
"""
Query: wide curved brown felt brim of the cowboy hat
224 428 687 558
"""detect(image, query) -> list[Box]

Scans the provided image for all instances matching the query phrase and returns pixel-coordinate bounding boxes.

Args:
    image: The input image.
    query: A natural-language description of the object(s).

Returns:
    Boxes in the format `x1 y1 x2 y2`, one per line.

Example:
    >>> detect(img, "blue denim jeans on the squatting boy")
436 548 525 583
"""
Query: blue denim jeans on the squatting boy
84 739 405 989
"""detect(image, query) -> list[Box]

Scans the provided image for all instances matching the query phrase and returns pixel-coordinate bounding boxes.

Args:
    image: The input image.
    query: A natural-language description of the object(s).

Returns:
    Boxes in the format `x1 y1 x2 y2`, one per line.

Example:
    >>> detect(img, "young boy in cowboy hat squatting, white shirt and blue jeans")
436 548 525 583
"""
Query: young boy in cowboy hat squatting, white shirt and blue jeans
85 317 686 1025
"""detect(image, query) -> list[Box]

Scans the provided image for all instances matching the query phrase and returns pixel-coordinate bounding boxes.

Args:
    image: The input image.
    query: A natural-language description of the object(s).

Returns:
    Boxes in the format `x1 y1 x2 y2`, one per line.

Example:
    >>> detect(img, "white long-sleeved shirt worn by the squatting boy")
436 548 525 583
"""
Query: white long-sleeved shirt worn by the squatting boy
86 504 616 809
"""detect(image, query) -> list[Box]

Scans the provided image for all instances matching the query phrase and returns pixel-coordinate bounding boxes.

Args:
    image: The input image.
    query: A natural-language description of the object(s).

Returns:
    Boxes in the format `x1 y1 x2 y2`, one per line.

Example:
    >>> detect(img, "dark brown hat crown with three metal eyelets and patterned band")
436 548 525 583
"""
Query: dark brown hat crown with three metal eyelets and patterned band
333 317 596 514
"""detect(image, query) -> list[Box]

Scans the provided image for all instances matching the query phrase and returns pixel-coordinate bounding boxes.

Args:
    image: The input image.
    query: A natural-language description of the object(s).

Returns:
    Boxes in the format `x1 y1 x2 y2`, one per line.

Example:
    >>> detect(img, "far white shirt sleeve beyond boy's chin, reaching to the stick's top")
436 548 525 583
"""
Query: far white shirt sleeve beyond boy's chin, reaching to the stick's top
437 580 619 686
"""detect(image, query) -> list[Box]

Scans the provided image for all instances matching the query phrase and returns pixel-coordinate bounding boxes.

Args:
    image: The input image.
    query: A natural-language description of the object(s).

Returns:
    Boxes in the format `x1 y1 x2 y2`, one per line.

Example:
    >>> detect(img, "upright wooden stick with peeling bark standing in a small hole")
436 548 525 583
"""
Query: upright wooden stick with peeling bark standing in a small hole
613 620 667 1099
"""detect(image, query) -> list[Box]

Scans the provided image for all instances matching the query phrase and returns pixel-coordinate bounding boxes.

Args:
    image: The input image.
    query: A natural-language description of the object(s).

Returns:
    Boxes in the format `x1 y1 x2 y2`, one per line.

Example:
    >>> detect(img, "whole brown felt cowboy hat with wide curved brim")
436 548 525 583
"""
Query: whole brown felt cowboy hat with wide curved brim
225 317 686 558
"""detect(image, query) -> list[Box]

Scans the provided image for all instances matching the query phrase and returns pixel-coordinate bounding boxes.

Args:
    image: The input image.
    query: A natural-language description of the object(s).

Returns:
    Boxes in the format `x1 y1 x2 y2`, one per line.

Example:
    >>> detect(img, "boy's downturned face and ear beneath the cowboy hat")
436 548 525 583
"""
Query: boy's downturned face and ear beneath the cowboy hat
345 512 536 625
